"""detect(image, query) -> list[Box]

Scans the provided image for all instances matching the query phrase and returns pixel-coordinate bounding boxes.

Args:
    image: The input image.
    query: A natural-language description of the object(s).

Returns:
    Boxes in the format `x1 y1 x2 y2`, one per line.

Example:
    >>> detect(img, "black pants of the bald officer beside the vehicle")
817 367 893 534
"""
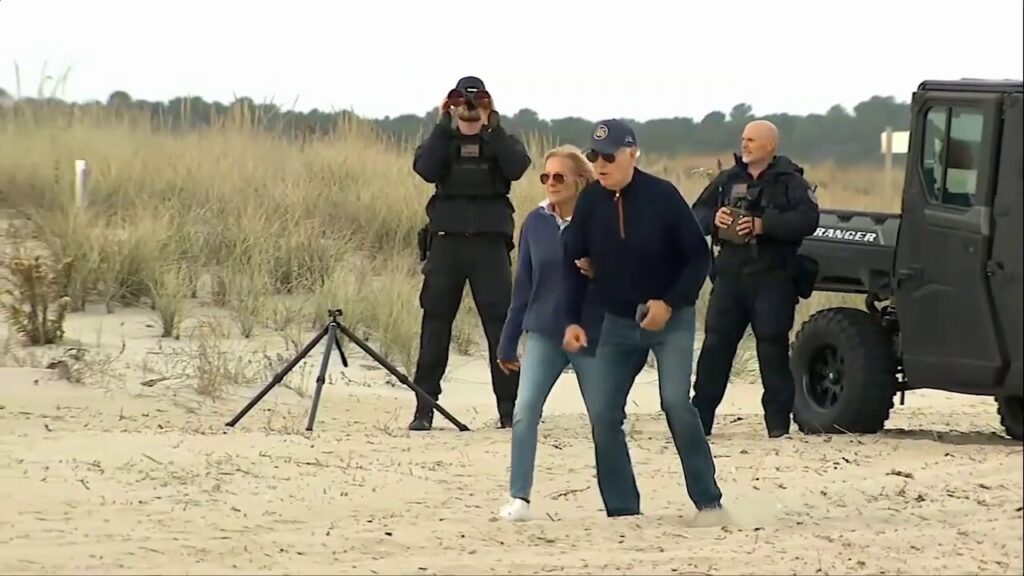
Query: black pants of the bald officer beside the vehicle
692 271 798 435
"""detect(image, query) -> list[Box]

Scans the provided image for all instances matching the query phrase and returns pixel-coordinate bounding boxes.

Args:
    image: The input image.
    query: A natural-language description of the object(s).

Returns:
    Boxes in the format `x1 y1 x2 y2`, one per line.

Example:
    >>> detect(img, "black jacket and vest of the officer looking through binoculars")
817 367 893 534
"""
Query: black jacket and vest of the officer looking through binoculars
413 122 530 237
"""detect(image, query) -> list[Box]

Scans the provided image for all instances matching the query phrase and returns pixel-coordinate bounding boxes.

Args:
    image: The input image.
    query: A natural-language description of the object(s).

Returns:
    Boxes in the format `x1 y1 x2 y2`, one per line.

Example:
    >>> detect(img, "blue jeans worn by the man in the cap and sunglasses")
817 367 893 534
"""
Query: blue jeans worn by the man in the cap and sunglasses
589 307 722 517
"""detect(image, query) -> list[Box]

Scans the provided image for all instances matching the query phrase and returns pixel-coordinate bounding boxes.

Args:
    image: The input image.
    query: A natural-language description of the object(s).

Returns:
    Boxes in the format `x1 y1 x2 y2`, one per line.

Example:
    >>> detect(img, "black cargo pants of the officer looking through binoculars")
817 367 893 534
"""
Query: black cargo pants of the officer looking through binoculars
414 234 519 417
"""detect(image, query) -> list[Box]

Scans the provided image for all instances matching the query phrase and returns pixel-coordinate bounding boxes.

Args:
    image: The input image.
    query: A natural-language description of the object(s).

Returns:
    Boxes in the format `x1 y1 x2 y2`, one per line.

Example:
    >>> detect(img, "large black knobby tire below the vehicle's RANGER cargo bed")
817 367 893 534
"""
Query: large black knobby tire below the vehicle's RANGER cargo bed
790 307 897 434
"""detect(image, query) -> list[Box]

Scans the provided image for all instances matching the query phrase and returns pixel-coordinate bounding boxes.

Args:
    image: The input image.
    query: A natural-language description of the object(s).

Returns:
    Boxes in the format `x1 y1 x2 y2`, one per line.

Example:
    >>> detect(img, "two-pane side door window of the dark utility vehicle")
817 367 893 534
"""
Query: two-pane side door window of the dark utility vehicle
921 107 984 208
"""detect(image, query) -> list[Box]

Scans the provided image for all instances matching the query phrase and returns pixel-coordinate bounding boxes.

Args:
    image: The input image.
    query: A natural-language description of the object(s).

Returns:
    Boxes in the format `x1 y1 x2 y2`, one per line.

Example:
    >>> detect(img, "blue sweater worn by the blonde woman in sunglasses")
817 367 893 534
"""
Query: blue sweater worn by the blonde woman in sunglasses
498 199 604 360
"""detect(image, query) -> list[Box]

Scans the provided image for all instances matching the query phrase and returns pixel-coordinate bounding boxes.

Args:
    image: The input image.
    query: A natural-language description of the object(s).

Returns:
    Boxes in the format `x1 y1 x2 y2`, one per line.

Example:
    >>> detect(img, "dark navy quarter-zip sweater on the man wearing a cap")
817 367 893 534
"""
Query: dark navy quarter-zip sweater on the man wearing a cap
562 168 711 325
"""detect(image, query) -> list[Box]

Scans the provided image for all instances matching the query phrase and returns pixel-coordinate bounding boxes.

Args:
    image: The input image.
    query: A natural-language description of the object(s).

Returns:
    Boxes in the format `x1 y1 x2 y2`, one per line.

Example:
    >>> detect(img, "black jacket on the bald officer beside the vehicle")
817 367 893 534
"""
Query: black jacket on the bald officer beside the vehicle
693 155 819 275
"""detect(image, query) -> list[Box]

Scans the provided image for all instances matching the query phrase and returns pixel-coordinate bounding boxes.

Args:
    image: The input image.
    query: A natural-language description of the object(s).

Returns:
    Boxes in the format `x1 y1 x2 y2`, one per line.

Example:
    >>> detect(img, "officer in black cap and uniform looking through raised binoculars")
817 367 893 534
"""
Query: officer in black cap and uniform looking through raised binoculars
409 76 530 430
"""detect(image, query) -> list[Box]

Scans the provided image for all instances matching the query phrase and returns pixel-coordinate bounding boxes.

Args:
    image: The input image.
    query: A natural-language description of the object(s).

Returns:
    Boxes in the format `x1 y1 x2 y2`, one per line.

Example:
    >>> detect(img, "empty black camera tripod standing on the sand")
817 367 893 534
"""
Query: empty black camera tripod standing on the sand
226 308 469 431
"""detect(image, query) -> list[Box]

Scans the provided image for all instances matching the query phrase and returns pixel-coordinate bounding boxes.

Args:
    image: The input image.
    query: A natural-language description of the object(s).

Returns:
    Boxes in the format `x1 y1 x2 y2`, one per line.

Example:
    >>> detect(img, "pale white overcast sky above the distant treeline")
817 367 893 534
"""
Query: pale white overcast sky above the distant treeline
0 0 1024 120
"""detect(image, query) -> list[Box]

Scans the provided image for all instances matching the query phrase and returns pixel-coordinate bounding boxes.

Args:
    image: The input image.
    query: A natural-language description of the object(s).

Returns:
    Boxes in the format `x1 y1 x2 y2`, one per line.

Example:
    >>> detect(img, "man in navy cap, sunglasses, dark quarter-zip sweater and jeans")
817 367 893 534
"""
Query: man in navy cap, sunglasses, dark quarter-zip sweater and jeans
563 120 722 517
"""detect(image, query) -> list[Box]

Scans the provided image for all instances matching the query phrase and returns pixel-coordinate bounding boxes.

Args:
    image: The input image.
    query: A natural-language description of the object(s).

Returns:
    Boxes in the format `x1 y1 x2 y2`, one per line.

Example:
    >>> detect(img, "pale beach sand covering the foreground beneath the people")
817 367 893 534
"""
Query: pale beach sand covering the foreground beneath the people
0 310 1024 574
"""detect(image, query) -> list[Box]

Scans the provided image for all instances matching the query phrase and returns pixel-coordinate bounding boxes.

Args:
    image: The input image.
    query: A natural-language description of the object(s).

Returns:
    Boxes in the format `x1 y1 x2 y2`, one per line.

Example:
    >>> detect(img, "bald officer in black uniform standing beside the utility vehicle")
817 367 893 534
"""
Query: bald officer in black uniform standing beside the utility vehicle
692 121 818 438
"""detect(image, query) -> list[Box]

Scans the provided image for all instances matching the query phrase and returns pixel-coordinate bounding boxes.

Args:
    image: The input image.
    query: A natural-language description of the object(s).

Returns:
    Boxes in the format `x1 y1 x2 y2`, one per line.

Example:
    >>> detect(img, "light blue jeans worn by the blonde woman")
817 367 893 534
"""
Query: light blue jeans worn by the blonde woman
509 332 596 501
